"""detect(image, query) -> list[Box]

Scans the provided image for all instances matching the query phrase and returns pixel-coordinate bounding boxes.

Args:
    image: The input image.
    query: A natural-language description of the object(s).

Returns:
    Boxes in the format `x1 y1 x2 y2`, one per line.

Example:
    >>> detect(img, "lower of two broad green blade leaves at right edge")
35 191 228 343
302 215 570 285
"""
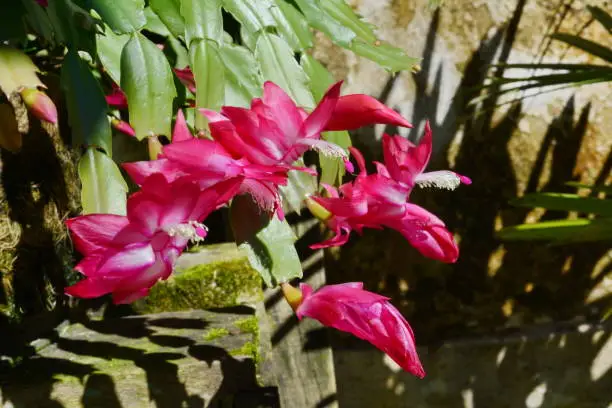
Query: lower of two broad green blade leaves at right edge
497 218 612 243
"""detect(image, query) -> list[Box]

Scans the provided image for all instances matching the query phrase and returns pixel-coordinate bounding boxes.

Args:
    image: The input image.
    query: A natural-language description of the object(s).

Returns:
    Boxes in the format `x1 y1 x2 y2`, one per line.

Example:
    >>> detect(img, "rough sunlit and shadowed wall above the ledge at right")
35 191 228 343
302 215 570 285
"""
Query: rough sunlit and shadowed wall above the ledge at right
315 0 612 341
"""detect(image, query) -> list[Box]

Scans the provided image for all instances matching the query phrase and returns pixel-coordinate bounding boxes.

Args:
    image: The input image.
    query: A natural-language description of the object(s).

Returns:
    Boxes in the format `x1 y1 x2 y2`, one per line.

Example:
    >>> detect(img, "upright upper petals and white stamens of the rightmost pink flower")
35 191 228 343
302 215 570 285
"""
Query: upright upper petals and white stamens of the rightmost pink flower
376 122 472 190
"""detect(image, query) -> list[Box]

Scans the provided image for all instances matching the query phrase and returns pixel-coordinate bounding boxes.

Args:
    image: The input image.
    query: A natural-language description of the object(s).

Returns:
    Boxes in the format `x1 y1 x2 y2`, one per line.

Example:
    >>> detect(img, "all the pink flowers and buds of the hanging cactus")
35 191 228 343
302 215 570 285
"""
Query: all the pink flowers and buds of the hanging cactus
67 79 469 377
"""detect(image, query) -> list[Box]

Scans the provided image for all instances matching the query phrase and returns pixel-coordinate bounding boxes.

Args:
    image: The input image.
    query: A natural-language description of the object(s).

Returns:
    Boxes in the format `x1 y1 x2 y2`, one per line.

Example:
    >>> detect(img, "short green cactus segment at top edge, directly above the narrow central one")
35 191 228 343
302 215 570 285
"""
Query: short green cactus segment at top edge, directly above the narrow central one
181 0 223 48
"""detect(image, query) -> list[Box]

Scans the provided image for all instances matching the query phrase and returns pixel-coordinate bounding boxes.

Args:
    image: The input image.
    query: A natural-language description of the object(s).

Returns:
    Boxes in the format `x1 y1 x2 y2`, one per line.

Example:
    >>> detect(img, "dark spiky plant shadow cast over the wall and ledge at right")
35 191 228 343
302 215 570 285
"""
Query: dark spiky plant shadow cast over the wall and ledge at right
326 0 612 408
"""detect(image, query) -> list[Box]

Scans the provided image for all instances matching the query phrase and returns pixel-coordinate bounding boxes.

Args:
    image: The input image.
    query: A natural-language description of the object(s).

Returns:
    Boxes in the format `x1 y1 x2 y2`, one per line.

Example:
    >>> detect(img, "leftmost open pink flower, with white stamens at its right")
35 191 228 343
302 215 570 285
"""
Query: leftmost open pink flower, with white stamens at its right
66 174 237 303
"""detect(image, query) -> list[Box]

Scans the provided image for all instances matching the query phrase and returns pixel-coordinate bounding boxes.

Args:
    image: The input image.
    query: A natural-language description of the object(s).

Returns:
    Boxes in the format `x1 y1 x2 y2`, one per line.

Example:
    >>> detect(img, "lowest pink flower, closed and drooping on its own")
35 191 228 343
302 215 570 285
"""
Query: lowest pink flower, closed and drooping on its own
281 282 425 378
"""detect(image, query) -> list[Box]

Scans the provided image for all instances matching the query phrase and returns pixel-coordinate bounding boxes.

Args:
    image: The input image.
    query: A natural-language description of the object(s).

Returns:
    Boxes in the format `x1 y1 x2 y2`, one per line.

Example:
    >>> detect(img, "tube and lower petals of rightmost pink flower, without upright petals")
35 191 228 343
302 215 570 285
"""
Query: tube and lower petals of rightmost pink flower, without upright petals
307 148 459 263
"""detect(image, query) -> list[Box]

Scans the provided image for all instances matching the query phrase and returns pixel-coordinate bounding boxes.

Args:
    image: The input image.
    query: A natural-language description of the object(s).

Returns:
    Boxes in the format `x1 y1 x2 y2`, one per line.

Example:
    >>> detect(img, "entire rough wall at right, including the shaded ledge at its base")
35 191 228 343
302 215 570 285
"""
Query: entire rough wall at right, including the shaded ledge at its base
315 0 612 408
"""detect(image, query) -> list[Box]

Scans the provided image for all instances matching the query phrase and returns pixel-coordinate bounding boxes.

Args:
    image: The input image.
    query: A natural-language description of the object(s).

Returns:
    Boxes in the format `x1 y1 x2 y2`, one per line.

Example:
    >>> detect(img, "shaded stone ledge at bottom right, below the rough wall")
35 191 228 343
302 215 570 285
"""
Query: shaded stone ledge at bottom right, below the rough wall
334 325 612 408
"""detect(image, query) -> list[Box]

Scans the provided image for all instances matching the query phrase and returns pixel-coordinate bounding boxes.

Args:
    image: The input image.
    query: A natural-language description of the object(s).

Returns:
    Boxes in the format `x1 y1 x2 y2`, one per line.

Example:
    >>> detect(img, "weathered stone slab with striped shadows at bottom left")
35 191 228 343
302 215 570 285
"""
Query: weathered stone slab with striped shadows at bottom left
0 307 278 408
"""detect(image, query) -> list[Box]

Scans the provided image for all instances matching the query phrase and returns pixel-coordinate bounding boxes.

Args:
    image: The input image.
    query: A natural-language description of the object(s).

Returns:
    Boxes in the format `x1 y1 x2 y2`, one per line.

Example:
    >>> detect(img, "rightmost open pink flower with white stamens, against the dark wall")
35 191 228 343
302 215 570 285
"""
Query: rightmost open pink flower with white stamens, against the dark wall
309 123 471 262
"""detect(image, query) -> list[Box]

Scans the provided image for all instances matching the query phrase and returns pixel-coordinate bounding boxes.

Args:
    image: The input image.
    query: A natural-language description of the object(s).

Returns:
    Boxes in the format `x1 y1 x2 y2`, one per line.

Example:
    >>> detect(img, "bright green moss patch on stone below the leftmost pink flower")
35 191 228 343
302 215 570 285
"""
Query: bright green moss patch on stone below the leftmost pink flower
134 258 263 313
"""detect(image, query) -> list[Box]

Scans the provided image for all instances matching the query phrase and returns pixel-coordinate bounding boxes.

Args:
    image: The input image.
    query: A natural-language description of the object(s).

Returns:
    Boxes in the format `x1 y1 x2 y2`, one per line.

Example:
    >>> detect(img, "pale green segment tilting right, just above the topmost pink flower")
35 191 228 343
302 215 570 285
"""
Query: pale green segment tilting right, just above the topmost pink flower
255 32 314 108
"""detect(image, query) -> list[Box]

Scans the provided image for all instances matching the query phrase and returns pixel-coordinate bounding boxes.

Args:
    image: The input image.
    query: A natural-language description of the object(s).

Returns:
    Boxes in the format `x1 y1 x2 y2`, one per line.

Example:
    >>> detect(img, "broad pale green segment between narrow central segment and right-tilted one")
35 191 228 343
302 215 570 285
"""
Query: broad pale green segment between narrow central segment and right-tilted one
220 45 263 106
